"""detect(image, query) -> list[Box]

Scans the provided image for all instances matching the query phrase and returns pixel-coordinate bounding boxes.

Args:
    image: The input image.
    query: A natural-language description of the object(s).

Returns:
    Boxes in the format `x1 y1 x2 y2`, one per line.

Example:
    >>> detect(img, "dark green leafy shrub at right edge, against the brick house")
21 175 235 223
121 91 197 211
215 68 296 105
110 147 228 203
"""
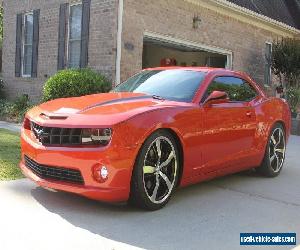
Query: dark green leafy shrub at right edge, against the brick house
271 38 300 87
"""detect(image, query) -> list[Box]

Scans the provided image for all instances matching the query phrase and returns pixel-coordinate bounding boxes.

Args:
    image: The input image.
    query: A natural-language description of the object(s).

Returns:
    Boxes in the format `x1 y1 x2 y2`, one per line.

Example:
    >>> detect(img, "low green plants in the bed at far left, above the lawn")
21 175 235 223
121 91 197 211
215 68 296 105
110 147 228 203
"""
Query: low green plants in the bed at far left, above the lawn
0 95 32 122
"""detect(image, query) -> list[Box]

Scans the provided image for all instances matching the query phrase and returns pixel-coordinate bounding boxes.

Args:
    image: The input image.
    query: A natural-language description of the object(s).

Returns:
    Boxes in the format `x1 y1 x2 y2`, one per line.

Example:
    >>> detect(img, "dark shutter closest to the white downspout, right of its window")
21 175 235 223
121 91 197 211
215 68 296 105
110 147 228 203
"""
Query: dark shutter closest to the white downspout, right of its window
80 0 91 68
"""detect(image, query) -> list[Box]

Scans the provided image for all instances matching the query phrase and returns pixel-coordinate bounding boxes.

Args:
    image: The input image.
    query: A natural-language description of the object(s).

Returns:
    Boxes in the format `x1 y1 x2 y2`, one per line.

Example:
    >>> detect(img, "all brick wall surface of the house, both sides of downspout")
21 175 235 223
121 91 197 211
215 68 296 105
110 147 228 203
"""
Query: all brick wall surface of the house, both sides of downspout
3 0 292 100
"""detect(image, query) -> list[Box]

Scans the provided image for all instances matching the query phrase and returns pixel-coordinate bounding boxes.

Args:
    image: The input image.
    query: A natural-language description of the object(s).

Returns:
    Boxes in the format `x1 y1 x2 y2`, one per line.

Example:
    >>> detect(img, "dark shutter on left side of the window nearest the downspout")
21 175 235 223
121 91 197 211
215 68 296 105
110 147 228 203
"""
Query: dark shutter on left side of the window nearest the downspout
57 3 69 70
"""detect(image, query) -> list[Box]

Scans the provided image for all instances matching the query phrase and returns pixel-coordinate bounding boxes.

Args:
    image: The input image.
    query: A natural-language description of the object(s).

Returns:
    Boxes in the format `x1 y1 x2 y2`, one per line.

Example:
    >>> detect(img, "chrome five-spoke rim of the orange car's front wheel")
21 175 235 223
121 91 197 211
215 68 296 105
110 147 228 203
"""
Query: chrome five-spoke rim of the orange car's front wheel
143 136 178 204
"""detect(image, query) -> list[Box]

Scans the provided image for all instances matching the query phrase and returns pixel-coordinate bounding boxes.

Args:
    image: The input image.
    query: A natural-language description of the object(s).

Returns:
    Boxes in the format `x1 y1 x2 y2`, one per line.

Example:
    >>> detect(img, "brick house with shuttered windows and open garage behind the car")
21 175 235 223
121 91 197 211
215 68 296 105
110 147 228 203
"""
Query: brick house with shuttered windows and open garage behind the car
3 0 300 100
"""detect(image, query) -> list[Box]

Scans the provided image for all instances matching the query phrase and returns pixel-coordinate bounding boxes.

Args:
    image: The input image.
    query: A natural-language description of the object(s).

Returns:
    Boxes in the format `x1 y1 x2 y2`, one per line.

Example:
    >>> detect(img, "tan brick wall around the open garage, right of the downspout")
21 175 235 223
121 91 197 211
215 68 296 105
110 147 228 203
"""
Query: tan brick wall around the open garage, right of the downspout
121 0 282 85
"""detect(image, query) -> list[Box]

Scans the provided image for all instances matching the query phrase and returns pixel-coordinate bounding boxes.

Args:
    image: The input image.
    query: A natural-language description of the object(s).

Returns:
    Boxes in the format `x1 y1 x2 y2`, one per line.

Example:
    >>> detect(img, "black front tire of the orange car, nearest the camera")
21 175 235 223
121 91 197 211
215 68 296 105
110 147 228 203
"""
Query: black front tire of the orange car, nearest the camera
129 130 181 211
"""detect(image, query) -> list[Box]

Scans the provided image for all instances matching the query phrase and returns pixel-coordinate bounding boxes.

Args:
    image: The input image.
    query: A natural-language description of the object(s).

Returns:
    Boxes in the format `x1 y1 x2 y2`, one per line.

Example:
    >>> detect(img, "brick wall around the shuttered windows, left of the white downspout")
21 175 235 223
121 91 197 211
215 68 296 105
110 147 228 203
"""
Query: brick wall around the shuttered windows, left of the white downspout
3 0 117 101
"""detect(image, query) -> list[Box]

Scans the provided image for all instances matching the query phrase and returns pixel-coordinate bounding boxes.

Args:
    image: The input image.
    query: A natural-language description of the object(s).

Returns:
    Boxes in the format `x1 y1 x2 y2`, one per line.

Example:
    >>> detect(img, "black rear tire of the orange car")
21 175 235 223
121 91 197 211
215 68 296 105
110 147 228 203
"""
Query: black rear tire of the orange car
256 123 286 177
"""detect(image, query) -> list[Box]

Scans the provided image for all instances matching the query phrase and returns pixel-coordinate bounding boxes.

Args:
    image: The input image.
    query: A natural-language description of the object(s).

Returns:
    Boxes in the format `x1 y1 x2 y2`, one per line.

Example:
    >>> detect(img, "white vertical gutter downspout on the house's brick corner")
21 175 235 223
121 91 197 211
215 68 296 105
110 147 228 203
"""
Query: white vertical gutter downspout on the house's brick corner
115 0 124 85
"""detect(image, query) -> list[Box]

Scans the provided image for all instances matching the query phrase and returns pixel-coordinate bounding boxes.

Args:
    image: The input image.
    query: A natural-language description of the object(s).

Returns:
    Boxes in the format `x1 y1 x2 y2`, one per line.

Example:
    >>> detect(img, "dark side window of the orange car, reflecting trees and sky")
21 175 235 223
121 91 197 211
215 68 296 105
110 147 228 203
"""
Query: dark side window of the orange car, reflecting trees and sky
206 76 257 102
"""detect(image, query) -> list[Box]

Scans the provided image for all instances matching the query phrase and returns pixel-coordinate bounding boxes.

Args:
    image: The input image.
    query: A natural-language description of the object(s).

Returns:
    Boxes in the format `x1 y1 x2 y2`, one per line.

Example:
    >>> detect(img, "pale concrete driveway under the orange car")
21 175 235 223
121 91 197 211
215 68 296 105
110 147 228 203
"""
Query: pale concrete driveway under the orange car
0 136 300 250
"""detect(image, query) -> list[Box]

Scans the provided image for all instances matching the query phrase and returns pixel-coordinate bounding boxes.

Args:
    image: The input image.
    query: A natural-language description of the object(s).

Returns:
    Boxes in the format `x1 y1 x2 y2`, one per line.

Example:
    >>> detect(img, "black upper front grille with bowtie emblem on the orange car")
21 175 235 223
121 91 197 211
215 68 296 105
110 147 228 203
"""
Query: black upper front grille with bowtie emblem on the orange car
31 122 82 146
